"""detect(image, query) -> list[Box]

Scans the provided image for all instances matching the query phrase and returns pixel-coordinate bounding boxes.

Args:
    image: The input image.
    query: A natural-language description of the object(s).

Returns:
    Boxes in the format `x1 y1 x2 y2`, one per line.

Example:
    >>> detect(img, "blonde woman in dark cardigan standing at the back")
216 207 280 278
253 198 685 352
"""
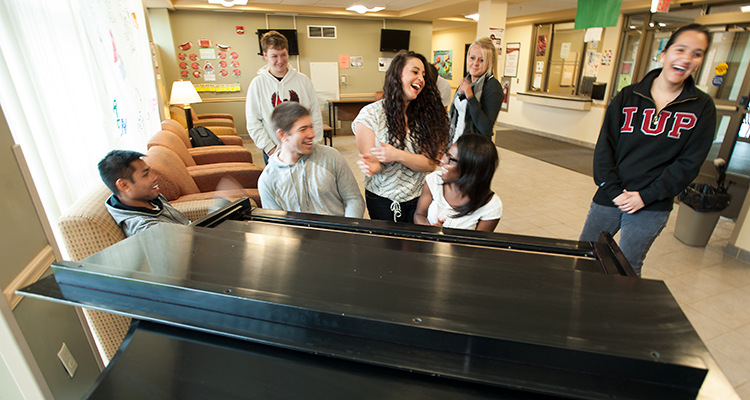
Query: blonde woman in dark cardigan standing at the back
448 37 503 143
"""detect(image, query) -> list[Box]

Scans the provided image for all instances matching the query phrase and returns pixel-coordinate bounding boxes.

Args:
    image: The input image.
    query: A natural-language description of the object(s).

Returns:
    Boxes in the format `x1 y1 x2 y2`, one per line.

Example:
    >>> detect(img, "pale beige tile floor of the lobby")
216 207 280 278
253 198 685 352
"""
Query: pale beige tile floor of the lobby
246 135 750 400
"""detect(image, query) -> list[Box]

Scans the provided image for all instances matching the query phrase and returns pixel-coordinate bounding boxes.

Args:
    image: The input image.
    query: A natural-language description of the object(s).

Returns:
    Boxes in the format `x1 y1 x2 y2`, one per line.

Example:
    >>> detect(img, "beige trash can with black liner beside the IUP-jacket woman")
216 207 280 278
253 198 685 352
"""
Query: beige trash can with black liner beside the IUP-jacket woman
674 158 731 246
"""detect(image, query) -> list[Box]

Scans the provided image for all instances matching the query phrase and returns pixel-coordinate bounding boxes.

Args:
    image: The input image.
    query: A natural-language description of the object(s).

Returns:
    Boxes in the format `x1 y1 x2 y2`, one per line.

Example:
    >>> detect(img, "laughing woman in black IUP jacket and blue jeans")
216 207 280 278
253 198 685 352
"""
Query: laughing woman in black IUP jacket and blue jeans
579 24 716 275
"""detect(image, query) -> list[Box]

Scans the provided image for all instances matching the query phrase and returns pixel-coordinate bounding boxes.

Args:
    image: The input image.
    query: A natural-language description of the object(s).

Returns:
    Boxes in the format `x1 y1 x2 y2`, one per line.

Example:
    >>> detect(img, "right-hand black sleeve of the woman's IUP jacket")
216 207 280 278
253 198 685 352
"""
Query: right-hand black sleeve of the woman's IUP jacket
639 96 716 205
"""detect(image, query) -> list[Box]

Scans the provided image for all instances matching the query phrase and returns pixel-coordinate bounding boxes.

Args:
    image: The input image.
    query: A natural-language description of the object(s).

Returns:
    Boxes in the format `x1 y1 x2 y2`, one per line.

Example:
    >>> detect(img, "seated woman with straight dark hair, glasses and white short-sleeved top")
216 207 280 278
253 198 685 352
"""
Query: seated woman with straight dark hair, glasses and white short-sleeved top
414 134 503 232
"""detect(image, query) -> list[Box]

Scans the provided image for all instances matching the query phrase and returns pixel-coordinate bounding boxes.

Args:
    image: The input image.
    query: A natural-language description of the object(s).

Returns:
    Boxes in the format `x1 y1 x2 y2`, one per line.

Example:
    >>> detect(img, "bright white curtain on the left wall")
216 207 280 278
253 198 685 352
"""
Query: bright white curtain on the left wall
0 0 160 252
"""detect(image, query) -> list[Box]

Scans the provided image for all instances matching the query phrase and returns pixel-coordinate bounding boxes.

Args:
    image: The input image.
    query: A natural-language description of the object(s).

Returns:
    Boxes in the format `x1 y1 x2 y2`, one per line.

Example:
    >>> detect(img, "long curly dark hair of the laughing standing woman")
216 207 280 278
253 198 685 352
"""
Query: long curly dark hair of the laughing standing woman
383 51 448 162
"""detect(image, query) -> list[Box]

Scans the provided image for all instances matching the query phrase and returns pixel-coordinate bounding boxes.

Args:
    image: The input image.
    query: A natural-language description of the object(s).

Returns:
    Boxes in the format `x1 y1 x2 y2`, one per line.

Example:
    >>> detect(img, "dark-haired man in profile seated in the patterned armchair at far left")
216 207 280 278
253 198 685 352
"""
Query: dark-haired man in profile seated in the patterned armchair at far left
99 150 190 236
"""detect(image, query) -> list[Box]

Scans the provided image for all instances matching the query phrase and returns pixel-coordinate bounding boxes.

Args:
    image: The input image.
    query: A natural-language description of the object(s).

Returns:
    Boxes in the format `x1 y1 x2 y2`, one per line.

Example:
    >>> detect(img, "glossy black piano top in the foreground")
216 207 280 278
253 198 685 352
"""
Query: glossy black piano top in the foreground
19 205 740 399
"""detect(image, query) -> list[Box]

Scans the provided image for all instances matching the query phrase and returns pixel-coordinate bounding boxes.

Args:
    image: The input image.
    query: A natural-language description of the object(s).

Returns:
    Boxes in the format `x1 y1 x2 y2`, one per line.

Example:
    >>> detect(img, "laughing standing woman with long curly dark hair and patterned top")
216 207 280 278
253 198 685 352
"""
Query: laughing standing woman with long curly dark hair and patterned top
352 51 448 222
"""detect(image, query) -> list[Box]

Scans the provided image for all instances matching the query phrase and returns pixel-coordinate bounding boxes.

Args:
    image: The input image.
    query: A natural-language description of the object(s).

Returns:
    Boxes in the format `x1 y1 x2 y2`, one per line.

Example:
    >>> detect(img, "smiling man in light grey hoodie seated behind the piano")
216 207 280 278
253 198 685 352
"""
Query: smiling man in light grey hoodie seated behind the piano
258 102 365 218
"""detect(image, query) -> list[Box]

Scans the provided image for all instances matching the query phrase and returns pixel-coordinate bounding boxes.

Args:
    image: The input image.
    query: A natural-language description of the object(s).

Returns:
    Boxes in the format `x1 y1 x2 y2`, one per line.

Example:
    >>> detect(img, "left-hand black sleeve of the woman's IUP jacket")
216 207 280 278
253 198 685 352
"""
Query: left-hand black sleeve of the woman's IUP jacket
594 88 629 200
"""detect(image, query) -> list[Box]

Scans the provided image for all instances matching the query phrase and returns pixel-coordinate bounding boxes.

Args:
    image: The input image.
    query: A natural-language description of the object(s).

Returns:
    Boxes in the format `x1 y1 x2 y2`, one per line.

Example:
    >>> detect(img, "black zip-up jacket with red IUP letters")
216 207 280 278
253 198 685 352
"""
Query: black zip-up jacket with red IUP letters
594 69 716 211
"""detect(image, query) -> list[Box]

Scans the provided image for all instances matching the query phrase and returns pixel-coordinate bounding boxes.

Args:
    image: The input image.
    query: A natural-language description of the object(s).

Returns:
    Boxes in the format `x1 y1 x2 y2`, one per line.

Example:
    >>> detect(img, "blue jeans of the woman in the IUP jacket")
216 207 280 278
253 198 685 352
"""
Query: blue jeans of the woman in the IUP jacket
578 202 670 276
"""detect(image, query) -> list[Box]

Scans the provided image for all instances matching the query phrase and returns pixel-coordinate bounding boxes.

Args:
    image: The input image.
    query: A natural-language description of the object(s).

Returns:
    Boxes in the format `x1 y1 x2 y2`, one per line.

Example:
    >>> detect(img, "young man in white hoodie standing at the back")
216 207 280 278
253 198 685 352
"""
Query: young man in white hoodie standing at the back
245 31 323 163
